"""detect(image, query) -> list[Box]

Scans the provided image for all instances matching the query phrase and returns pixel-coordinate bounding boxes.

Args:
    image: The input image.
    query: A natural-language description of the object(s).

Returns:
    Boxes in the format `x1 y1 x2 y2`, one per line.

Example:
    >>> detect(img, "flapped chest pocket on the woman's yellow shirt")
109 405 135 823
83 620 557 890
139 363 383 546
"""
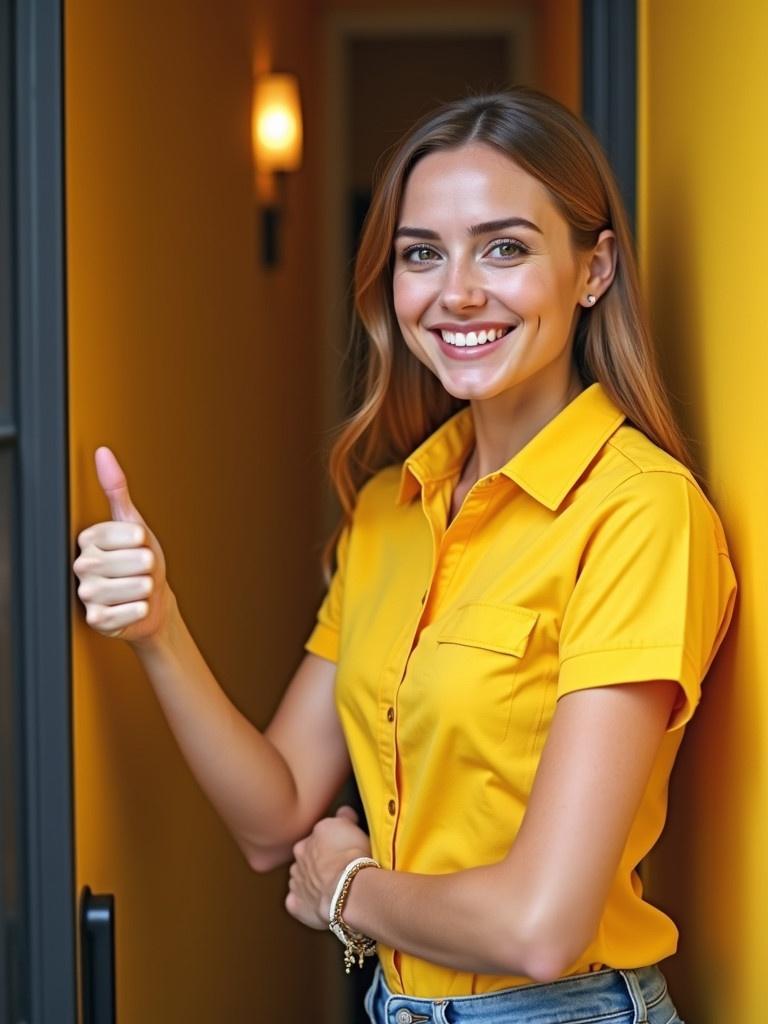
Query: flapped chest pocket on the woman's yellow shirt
431 602 541 749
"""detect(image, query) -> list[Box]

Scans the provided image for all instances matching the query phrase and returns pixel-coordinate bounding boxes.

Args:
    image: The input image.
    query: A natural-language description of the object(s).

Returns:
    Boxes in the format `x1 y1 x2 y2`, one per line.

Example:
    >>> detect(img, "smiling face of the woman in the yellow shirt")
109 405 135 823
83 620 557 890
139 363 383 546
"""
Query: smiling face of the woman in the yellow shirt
392 142 611 399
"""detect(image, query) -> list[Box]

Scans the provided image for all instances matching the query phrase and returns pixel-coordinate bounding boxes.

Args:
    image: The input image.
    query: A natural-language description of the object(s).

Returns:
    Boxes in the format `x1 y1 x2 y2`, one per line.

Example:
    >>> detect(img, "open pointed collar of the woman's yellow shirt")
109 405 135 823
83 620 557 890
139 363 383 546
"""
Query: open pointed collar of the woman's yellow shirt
396 381 626 511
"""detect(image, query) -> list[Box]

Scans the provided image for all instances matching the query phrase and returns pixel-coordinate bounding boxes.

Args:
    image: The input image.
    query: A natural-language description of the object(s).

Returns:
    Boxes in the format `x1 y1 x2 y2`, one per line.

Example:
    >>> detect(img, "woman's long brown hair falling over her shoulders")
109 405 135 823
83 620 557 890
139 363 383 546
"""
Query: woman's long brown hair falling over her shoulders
324 86 697 574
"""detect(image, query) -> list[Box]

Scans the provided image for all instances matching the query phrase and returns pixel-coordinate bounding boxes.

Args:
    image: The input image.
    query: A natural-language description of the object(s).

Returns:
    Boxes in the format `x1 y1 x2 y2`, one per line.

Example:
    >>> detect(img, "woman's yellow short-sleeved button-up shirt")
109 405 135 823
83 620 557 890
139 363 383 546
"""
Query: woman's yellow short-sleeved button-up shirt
306 383 736 996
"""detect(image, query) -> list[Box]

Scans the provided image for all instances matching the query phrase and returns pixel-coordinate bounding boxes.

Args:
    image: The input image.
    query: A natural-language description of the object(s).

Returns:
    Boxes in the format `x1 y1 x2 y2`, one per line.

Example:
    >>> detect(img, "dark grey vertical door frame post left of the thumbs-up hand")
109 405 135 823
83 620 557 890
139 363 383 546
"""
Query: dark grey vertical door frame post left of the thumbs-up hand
0 0 77 1024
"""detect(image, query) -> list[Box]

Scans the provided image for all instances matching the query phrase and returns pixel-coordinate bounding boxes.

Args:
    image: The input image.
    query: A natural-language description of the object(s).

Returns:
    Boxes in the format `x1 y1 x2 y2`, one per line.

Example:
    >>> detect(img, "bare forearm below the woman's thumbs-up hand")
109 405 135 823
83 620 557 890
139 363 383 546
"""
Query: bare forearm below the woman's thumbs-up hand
131 594 298 863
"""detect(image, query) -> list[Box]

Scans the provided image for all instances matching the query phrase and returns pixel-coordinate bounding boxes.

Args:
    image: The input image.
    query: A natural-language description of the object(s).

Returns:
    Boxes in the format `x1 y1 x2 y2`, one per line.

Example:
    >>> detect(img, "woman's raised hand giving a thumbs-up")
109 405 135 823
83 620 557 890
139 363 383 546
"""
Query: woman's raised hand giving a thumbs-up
72 447 174 643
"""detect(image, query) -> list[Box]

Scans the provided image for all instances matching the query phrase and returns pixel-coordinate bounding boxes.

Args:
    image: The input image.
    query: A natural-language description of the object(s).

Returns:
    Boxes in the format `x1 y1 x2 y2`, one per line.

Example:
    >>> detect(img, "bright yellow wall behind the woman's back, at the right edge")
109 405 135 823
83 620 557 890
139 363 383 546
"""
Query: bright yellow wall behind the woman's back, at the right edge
639 0 768 1024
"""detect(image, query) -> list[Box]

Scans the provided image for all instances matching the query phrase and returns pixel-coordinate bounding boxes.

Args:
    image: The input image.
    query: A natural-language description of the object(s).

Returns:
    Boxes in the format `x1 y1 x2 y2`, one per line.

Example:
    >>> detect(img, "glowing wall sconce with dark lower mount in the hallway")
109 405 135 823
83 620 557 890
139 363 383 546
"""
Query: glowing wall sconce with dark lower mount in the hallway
252 74 303 266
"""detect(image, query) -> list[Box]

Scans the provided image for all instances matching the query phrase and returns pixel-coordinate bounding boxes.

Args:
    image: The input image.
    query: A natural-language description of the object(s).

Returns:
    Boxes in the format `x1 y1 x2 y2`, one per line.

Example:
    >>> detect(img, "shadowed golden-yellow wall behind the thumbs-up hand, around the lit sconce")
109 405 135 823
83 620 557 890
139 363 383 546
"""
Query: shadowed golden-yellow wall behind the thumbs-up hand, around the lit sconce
66 0 333 1024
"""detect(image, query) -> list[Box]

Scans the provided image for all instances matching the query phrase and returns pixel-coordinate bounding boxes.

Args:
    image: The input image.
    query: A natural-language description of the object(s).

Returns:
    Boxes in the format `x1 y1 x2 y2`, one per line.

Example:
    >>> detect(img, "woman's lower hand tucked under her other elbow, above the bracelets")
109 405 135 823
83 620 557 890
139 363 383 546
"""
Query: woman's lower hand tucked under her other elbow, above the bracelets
286 805 371 930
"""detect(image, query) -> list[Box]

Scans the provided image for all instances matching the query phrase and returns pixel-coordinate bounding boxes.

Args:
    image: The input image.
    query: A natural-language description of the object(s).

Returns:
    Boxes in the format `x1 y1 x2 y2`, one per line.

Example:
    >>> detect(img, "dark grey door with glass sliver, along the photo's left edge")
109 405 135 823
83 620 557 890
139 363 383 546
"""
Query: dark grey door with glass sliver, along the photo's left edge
0 0 76 1024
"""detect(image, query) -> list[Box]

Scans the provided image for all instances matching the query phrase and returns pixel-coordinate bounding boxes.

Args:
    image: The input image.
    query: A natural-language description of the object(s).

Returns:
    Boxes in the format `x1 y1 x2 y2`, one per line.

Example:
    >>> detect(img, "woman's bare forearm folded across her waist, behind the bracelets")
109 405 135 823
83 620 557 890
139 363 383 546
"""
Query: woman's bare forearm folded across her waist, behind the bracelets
343 864 536 977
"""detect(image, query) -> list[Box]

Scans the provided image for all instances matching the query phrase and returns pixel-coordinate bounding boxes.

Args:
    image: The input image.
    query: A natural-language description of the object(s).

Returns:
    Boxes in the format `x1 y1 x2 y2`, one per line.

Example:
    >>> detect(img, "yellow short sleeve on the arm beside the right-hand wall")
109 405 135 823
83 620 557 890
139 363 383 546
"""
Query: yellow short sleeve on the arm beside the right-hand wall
557 471 736 731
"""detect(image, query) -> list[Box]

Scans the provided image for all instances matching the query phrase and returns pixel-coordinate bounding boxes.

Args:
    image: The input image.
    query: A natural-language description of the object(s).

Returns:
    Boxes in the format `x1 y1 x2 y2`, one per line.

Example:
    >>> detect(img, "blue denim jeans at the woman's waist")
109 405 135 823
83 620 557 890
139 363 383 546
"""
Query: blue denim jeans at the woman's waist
366 964 683 1024
